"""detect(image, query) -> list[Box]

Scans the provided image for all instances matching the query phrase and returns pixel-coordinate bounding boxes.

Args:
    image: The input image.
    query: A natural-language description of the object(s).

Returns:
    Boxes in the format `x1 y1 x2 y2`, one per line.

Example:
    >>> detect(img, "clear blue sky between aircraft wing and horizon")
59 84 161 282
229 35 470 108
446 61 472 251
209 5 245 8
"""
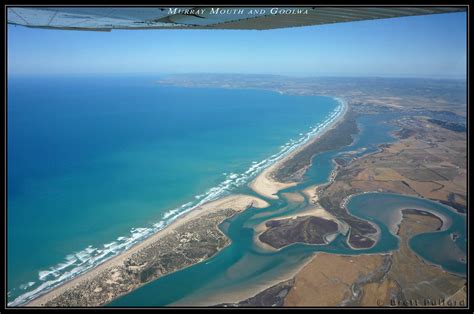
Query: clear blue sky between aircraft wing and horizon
8 13 466 78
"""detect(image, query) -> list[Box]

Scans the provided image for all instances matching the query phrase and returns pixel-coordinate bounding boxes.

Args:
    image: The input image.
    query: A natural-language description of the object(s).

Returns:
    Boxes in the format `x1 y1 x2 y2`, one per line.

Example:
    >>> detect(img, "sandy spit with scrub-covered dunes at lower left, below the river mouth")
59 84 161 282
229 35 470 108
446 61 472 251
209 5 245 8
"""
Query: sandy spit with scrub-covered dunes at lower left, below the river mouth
26 194 269 307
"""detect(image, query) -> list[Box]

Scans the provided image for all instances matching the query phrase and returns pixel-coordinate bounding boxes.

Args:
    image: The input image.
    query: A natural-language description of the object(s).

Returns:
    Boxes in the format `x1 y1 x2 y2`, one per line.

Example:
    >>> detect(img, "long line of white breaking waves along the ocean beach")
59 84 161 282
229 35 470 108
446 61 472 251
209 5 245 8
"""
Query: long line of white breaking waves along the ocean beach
8 98 345 306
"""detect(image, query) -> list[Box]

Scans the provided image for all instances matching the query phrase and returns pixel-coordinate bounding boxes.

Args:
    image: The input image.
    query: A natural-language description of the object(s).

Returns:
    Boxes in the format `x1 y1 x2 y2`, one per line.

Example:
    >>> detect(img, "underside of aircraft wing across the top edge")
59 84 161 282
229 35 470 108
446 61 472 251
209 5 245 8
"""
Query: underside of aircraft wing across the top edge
7 6 466 31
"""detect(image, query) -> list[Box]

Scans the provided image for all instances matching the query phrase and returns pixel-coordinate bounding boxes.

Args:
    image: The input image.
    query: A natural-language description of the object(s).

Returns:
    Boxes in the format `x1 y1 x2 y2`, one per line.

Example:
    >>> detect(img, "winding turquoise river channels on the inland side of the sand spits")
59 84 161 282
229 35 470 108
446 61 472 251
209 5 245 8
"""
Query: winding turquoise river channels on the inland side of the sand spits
108 113 466 306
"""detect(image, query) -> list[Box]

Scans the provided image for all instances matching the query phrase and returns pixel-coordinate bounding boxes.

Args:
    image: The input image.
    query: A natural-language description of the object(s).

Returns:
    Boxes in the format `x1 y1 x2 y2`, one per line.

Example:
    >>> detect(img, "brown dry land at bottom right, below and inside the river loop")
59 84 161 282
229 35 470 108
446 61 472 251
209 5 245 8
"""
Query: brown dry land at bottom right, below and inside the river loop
285 213 466 306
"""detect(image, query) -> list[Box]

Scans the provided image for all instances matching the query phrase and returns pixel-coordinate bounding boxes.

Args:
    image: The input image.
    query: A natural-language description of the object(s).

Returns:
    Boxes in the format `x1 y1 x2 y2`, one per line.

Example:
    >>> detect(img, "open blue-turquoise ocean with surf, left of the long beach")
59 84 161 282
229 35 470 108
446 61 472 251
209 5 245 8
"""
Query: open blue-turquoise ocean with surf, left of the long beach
7 76 338 305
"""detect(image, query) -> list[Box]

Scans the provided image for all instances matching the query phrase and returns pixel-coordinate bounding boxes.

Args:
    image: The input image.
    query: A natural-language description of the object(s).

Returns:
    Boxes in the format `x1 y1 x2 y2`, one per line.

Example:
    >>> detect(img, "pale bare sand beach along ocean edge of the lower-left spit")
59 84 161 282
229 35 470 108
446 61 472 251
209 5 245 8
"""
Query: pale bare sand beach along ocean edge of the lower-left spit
26 194 268 307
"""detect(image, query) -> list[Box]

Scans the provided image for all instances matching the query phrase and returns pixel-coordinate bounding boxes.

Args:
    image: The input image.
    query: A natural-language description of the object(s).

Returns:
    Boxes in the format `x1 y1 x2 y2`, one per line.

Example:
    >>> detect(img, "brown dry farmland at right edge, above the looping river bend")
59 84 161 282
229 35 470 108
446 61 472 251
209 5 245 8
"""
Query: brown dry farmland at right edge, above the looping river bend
336 114 467 210
